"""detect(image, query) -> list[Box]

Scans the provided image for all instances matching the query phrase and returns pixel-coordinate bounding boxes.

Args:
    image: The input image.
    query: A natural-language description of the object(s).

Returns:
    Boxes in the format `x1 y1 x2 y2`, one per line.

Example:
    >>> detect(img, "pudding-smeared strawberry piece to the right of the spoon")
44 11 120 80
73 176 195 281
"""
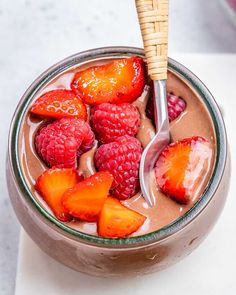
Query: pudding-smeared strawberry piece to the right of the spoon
155 136 213 204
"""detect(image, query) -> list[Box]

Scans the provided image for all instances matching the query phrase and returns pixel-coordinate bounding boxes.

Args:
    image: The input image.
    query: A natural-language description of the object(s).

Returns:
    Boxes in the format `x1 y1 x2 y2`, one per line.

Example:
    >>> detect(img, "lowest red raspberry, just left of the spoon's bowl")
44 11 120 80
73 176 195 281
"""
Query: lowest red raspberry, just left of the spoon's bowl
95 135 142 200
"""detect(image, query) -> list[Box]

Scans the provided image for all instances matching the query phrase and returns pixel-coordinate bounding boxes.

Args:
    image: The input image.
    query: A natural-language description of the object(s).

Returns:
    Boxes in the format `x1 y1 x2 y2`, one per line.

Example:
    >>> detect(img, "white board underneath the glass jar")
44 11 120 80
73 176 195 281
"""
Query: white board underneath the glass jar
15 55 236 295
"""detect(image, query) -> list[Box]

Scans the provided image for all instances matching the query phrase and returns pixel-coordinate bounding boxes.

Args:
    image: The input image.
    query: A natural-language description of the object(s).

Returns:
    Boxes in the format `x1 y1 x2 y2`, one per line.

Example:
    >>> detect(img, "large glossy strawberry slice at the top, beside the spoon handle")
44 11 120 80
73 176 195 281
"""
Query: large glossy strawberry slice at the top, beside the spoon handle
71 56 145 105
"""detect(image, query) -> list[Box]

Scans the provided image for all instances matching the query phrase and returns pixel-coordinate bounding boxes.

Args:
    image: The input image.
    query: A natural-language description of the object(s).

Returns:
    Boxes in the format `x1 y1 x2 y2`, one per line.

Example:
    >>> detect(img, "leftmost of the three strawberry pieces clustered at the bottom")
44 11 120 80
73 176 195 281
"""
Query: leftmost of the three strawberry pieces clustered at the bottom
35 168 80 221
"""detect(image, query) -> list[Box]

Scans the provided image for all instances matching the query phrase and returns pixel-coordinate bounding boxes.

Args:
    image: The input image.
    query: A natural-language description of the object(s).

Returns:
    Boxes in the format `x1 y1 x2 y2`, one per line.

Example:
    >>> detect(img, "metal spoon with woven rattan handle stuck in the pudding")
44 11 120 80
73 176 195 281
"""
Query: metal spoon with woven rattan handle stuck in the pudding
135 0 170 207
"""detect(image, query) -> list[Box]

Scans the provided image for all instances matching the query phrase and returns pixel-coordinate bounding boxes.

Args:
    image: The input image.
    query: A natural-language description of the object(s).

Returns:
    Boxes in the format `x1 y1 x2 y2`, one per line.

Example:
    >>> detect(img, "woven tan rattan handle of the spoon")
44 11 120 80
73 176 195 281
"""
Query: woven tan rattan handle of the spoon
135 0 169 80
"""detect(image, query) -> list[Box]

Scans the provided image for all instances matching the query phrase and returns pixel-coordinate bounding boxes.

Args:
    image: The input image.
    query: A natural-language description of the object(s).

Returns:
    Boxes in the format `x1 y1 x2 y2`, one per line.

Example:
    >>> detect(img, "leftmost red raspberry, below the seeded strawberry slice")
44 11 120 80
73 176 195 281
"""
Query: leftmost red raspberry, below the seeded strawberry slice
35 118 94 168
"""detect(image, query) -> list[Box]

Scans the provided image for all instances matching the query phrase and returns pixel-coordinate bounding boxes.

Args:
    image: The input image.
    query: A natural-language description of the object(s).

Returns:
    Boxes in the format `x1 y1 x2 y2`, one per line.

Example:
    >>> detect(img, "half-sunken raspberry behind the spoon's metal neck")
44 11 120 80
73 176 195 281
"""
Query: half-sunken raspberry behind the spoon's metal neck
146 93 186 122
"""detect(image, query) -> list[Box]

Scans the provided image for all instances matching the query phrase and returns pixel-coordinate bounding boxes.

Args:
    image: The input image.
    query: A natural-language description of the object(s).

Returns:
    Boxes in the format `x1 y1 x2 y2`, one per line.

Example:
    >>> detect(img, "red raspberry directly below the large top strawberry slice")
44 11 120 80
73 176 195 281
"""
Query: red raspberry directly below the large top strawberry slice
90 103 140 143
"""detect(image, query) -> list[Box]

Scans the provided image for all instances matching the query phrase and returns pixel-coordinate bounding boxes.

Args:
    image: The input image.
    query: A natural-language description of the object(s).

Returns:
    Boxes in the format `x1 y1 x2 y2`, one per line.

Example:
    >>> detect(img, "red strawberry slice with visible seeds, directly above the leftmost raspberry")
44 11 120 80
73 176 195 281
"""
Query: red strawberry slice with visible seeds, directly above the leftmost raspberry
30 89 87 120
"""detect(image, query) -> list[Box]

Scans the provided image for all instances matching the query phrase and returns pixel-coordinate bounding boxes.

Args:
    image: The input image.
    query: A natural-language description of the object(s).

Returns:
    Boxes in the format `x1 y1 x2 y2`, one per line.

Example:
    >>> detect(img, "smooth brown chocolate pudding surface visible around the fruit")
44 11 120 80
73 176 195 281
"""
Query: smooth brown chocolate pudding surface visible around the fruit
19 59 215 236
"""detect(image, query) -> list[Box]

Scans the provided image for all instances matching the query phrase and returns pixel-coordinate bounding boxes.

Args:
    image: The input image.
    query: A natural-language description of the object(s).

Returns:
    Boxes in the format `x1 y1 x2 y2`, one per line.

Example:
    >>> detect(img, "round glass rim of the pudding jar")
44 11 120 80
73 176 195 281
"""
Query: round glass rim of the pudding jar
8 46 227 248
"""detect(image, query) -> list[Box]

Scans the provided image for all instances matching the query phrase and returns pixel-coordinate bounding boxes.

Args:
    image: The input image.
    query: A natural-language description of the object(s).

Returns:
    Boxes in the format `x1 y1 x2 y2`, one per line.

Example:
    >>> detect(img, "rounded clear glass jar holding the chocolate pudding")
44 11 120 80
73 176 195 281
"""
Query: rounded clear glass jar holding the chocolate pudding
7 47 230 276
